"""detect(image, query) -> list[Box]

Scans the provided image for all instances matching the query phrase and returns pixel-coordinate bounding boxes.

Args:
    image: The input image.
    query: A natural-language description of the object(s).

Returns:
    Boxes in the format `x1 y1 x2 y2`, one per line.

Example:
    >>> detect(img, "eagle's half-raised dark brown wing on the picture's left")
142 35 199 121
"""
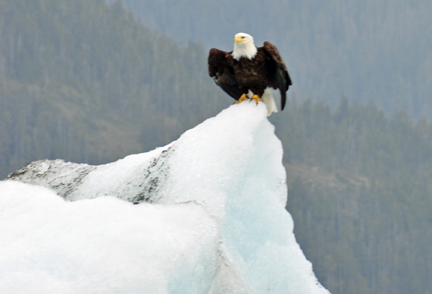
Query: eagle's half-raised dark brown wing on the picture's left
208 48 243 100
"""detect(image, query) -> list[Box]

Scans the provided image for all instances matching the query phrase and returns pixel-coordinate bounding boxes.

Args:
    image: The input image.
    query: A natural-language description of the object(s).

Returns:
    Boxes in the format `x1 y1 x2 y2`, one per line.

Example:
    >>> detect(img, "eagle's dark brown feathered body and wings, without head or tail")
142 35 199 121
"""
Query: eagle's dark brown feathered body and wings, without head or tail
208 38 292 110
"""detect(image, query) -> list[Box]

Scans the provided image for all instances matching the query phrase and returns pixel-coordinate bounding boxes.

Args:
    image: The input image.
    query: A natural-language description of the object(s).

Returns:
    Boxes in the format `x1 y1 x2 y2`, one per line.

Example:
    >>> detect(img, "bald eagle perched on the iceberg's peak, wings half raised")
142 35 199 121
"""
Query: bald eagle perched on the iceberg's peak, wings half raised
208 33 292 115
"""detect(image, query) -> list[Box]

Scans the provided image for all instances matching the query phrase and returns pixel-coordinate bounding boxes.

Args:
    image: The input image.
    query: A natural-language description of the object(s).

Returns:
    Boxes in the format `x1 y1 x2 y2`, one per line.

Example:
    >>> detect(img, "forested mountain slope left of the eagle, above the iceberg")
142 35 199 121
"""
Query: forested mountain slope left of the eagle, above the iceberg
0 0 230 176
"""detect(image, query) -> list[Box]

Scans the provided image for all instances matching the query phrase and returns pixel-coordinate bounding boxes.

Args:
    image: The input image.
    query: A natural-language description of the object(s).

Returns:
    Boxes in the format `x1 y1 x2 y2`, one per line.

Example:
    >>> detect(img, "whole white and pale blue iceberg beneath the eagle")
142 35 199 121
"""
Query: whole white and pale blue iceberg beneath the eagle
0 102 329 294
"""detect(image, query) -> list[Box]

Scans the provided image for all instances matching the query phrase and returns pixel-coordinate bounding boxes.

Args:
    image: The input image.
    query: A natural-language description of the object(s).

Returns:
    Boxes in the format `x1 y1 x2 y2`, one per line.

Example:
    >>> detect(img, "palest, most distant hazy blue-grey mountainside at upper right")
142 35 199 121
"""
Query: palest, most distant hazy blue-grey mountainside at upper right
124 0 432 120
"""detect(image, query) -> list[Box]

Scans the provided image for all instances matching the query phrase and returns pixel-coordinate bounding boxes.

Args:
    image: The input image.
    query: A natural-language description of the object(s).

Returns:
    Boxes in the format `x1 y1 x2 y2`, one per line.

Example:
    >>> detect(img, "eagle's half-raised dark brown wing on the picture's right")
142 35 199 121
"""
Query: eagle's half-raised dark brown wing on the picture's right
263 42 292 110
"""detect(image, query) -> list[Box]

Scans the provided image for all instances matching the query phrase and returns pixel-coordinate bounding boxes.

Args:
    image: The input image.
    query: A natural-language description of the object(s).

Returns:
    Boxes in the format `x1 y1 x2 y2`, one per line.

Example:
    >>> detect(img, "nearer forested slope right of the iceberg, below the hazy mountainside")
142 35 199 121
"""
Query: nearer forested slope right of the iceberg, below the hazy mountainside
282 99 432 294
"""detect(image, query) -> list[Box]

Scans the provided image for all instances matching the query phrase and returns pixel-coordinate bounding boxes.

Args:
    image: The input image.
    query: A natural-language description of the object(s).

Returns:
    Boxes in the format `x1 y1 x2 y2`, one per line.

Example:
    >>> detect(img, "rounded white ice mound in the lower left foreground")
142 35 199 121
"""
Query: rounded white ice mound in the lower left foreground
0 181 219 294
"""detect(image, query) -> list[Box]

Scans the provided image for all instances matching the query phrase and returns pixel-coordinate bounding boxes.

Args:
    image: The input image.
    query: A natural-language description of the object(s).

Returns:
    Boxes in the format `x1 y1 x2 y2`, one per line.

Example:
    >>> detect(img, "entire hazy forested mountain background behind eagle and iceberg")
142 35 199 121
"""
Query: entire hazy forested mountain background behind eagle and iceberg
0 0 432 294
